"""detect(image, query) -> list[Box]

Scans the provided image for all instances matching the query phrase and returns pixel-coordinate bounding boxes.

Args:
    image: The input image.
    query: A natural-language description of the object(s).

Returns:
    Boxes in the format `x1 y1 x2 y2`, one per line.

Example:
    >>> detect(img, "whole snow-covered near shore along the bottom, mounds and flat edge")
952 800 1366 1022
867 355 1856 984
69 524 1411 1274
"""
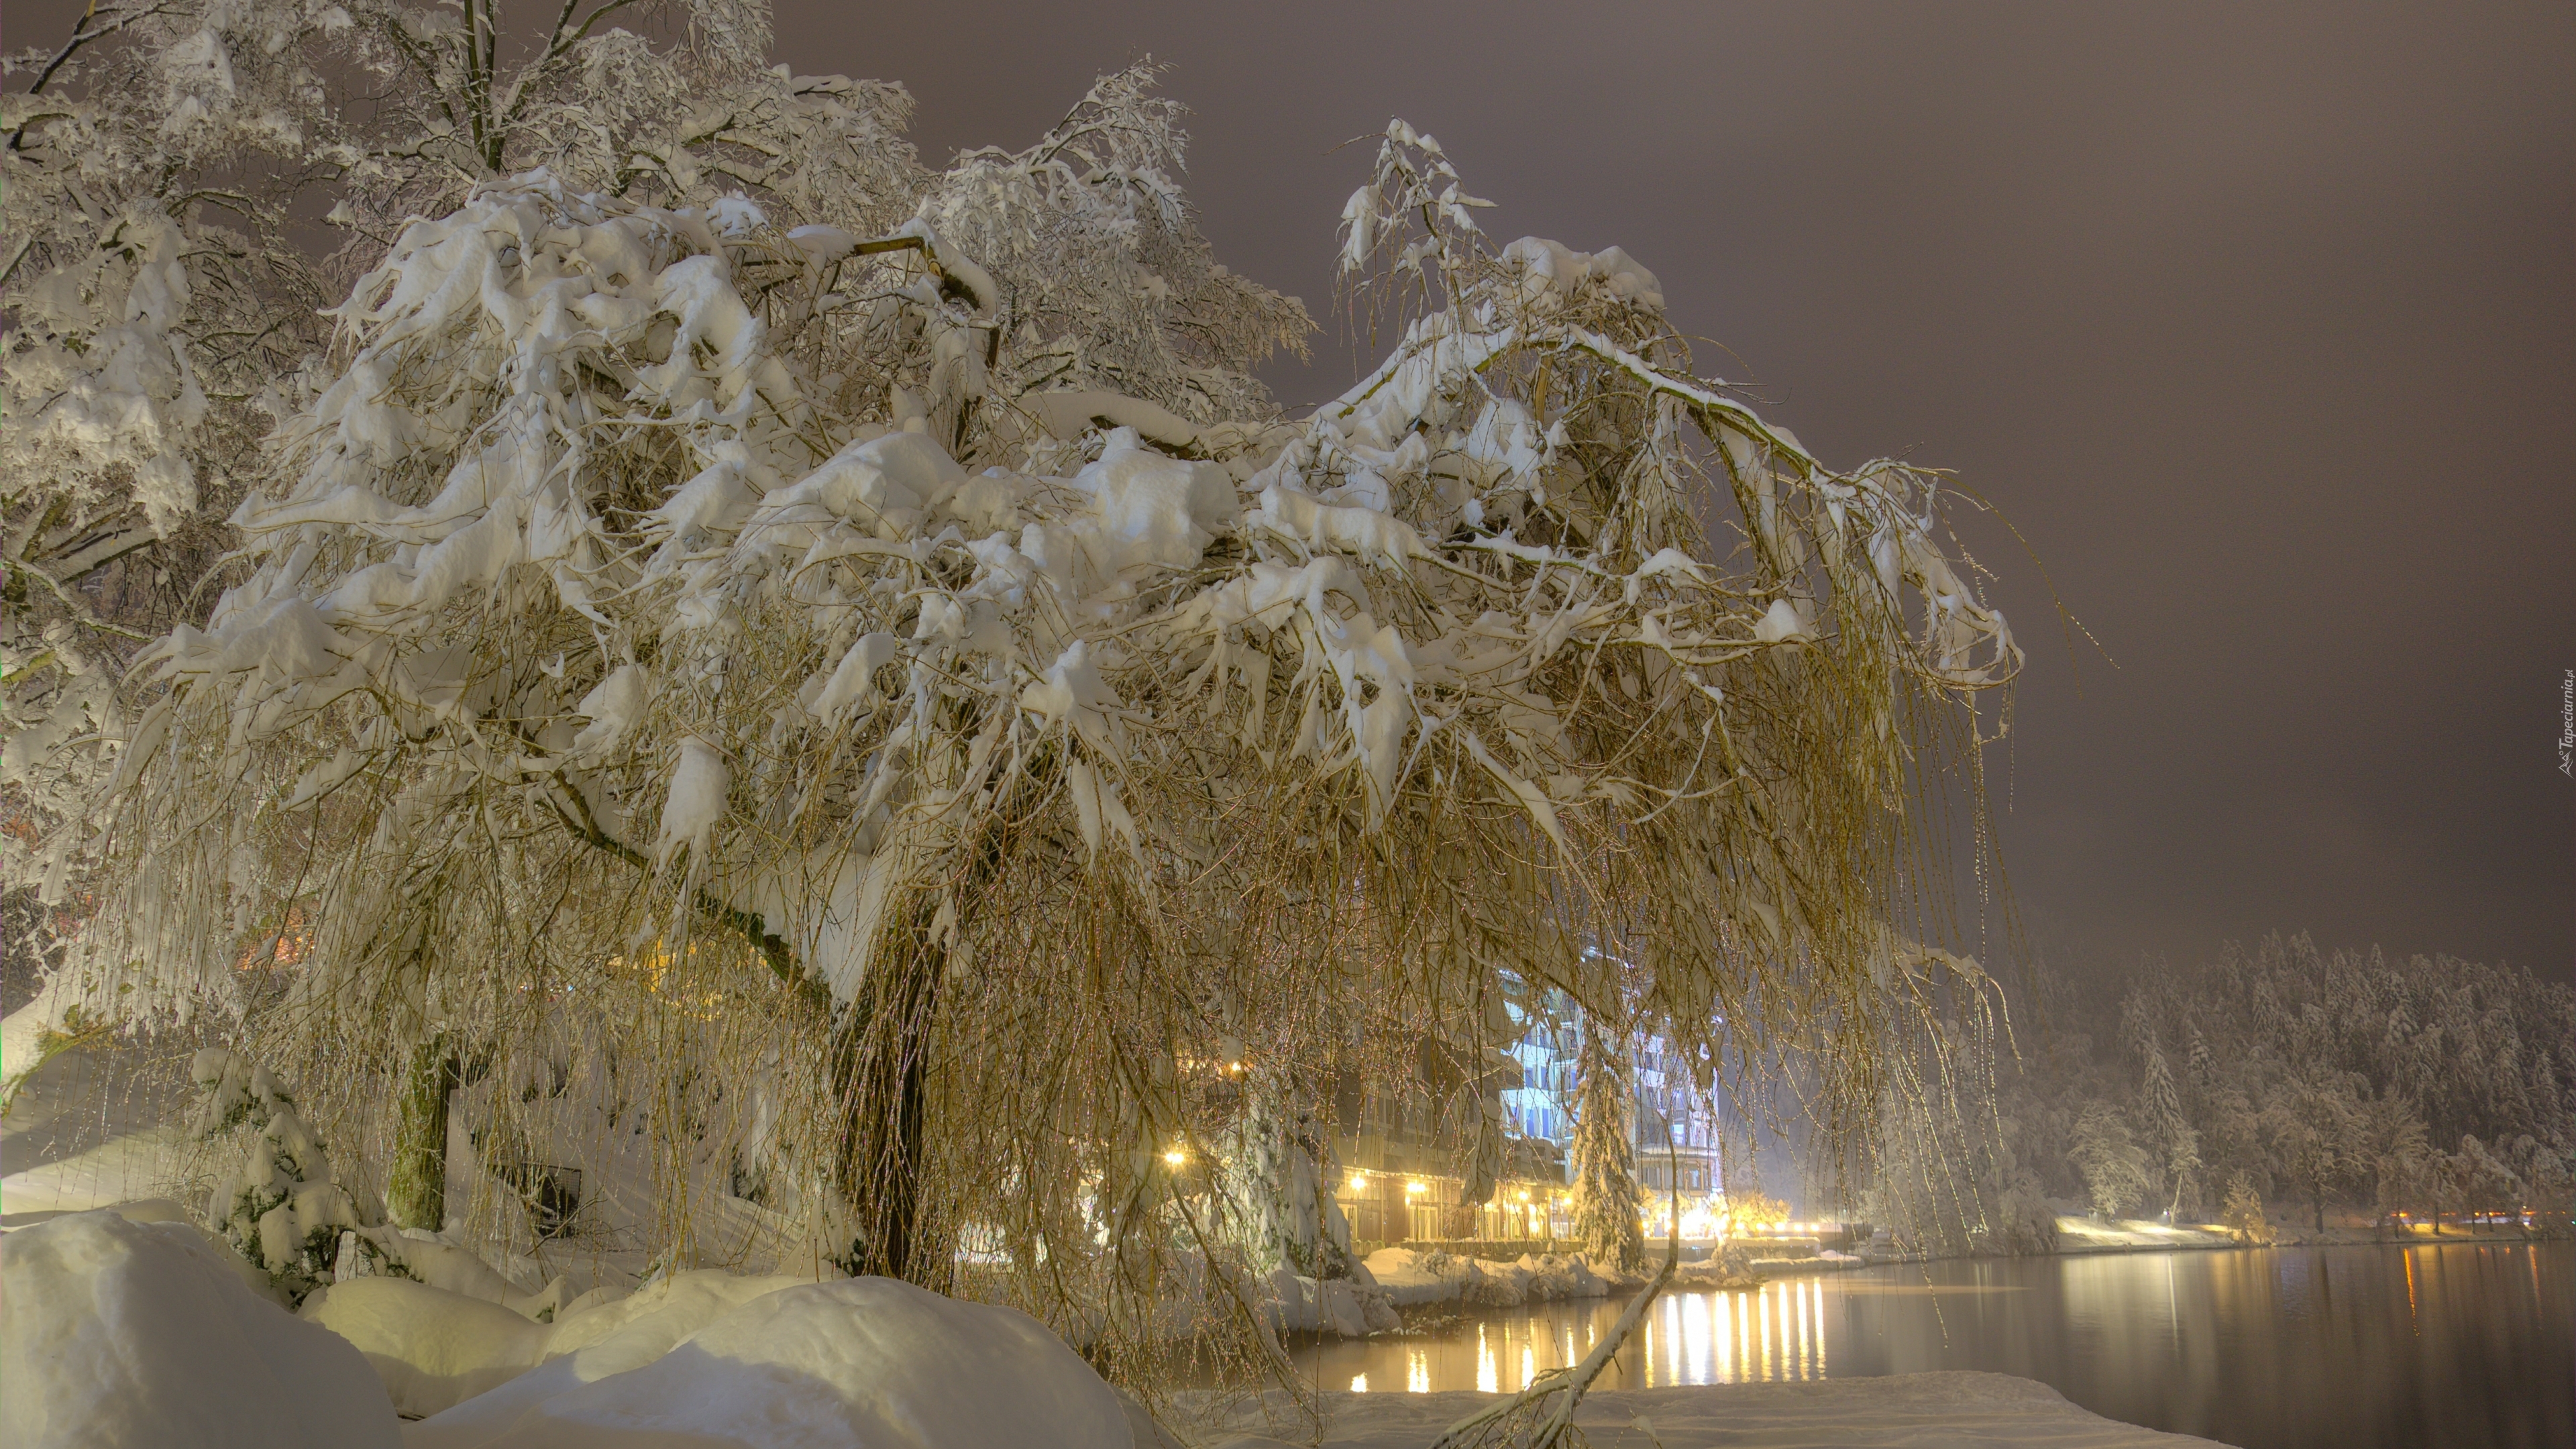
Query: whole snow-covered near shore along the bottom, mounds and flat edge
0 1212 2205 1449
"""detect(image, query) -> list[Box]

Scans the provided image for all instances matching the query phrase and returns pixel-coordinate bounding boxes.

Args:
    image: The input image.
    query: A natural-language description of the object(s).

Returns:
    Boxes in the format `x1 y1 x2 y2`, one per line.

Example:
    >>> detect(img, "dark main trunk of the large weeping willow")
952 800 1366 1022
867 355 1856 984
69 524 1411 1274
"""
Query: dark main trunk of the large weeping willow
832 898 948 1287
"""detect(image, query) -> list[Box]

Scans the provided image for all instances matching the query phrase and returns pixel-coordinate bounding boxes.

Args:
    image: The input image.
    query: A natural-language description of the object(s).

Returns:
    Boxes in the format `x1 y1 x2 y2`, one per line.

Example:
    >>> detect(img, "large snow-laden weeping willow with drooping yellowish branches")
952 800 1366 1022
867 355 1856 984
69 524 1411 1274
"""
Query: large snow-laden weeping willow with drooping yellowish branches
60 113 2020 1372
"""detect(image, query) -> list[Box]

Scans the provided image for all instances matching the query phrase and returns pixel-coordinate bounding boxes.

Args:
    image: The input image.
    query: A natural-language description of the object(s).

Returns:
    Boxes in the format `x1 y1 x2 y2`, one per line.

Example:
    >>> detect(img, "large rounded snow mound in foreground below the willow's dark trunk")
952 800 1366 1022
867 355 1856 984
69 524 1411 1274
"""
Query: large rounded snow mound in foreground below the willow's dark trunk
405 1274 1134 1449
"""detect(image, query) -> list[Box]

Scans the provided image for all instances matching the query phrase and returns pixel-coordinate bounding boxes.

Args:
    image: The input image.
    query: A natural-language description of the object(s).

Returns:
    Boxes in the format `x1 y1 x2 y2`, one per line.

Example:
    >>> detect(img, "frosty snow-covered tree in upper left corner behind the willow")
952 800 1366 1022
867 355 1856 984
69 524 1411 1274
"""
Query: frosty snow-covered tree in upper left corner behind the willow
0 0 925 969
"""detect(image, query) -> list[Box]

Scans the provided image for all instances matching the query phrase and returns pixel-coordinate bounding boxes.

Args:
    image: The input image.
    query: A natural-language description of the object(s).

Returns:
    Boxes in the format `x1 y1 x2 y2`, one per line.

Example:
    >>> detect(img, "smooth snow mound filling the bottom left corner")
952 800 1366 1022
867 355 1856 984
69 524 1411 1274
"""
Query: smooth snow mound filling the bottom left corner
0 1212 402 1449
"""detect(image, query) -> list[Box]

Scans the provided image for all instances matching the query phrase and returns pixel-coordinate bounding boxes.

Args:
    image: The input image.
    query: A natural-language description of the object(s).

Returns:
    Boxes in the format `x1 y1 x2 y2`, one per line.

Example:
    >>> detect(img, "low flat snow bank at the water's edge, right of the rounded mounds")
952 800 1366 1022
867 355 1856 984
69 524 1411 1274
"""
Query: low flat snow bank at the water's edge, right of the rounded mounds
1183 1372 2210 1449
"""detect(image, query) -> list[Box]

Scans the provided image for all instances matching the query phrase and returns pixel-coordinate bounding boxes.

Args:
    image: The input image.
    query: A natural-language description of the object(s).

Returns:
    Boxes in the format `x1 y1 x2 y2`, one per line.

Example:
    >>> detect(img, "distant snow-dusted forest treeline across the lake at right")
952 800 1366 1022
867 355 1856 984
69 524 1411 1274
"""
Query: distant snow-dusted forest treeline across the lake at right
1868 936 2576 1253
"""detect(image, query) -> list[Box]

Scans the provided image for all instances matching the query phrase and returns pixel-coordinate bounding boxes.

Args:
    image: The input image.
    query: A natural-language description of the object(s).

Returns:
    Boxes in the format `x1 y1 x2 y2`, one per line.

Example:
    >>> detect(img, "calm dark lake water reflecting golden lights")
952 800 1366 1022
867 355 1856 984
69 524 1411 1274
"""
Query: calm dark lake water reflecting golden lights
1298 1243 2576 1449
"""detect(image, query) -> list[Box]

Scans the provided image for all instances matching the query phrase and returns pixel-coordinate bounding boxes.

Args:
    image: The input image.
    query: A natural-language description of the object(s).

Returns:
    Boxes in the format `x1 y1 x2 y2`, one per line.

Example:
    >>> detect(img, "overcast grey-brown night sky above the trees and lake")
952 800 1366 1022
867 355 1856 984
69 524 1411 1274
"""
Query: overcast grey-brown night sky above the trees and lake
778 0 2576 979
